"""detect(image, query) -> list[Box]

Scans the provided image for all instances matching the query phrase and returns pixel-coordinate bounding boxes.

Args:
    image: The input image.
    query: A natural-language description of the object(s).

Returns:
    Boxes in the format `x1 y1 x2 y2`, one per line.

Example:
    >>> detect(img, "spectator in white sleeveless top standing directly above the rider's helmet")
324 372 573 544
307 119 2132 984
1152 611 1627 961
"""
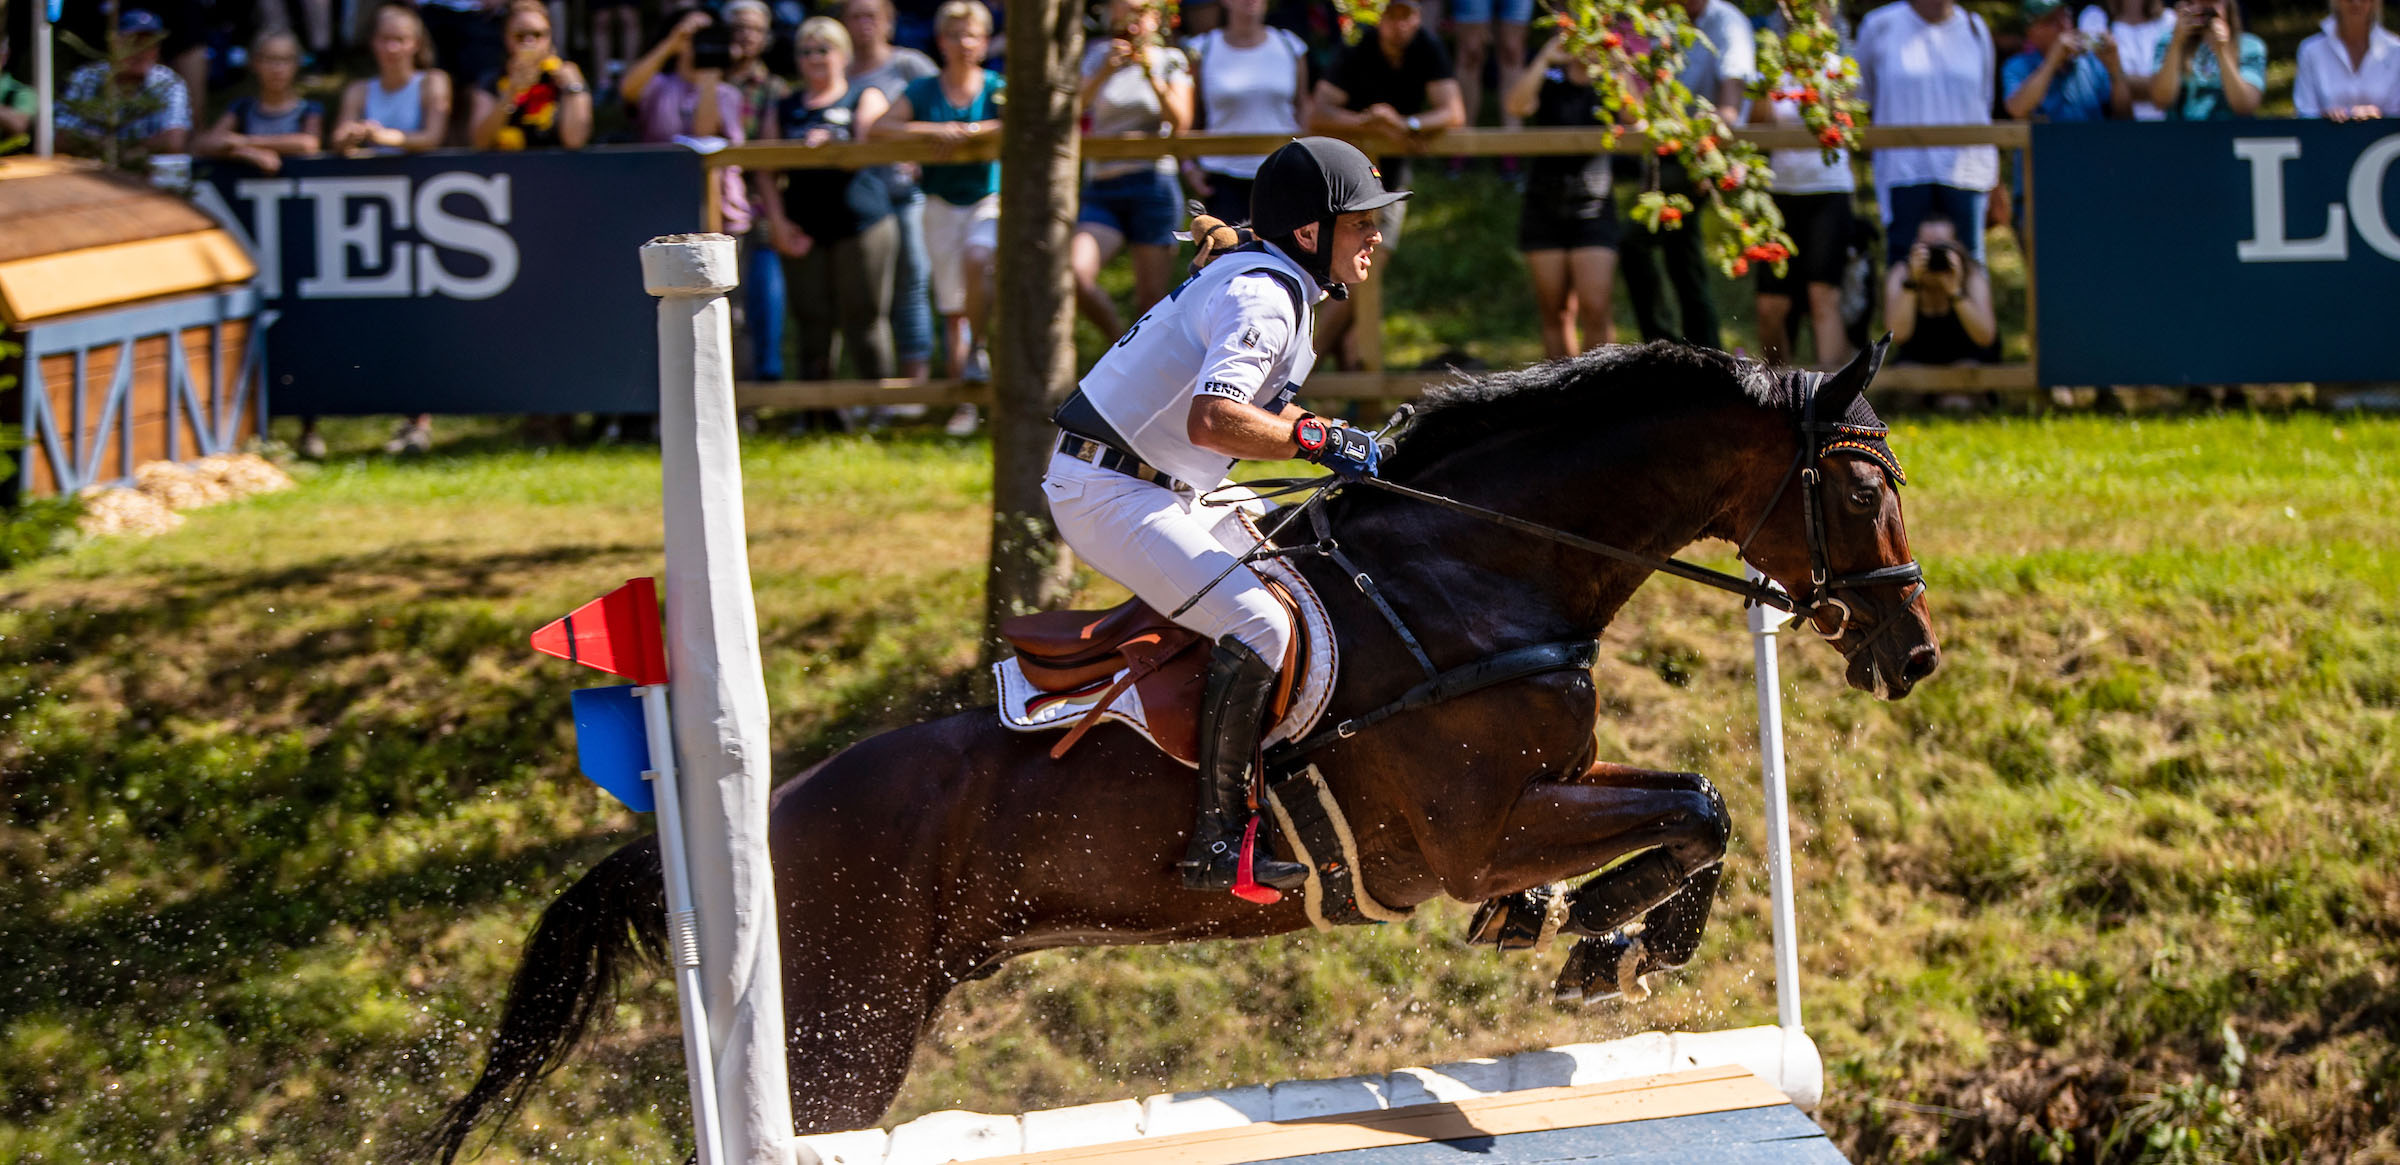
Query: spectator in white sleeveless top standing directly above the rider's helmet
1183 0 1308 223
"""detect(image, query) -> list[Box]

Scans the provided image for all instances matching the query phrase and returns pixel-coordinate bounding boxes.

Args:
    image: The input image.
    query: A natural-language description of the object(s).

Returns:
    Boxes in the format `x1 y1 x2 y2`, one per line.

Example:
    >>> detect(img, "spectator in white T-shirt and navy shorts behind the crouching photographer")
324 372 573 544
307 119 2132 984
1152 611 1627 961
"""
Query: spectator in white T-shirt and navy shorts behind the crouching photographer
1858 0 1999 262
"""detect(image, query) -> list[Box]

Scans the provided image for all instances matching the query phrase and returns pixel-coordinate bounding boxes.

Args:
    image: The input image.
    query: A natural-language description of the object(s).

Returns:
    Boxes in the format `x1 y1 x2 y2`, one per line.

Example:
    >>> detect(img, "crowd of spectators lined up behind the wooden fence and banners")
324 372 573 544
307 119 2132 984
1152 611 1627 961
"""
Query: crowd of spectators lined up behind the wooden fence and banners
0 0 2400 437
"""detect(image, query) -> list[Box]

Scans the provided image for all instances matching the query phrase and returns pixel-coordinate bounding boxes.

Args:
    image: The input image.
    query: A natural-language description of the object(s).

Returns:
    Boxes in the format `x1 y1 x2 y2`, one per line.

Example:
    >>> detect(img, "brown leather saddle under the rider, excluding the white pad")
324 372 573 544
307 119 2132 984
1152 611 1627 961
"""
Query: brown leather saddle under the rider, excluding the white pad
1001 579 1308 764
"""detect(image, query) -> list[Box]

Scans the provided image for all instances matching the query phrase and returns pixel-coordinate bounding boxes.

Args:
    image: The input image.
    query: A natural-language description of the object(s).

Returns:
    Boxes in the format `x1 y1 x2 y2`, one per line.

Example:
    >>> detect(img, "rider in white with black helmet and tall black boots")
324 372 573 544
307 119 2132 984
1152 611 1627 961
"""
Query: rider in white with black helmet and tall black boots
1042 137 1409 891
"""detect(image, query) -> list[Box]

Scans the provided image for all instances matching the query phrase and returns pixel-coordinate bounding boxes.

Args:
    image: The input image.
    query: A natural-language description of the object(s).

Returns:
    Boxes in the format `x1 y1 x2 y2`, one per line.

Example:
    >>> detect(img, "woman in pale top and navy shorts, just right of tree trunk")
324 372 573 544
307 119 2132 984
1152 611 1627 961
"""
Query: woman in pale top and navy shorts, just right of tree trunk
1068 0 1193 339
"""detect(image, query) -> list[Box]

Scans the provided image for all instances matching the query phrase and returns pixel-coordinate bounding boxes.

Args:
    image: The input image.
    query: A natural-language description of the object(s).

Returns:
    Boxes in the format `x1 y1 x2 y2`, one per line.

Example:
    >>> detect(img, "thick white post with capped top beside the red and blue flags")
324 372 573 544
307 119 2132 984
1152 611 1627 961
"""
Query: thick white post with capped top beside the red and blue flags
641 235 797 1165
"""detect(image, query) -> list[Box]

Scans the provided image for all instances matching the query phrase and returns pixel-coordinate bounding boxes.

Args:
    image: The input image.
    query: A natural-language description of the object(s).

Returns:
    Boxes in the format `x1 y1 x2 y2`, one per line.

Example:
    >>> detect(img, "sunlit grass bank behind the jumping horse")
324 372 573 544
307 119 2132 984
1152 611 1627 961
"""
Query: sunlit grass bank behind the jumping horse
0 403 2400 1163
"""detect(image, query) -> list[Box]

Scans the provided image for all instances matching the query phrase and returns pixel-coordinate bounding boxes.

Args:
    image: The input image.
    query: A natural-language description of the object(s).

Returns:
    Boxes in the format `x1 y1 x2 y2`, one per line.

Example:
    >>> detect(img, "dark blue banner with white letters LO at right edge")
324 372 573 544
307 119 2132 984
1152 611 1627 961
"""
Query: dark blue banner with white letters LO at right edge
2033 120 2400 384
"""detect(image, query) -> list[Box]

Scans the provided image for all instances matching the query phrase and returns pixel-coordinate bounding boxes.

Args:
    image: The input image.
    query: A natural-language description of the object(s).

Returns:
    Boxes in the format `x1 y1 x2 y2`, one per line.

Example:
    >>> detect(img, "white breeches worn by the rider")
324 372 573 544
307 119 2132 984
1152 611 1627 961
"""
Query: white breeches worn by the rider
1042 454 1291 668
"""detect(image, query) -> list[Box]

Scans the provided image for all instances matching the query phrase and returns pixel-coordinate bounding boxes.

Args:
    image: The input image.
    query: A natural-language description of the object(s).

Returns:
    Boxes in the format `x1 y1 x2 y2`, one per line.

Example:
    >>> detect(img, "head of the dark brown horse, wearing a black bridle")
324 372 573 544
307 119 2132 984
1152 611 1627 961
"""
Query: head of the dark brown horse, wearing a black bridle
1742 341 1942 699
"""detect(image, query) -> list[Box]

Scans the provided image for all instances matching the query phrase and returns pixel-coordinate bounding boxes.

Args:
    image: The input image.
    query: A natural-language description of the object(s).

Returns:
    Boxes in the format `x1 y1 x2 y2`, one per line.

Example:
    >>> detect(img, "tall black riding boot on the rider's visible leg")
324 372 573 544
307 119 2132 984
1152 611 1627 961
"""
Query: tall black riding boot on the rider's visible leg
1181 637 1308 891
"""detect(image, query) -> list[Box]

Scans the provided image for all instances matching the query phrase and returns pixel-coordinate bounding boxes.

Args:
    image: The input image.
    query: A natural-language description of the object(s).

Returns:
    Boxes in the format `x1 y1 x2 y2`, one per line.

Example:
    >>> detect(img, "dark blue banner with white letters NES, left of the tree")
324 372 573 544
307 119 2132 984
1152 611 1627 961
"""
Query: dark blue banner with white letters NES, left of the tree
194 147 701 416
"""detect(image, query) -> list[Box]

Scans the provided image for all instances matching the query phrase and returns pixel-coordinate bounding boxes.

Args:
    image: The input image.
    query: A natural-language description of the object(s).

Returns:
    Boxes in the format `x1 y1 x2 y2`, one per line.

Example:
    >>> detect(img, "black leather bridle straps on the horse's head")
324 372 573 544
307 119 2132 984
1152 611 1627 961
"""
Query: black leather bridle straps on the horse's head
1738 372 1925 658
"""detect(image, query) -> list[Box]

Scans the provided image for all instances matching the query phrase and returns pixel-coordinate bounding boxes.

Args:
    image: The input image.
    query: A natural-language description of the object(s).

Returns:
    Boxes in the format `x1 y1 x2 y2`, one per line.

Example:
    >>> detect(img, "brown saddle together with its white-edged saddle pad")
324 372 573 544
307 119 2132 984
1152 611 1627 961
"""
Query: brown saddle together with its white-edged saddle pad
994 562 1334 766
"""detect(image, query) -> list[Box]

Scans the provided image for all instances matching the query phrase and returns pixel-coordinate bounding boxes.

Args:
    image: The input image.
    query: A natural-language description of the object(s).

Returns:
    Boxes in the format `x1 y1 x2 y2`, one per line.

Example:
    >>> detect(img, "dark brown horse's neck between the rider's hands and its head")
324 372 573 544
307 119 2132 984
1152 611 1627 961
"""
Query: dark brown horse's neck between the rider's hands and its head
1342 408 1764 653
